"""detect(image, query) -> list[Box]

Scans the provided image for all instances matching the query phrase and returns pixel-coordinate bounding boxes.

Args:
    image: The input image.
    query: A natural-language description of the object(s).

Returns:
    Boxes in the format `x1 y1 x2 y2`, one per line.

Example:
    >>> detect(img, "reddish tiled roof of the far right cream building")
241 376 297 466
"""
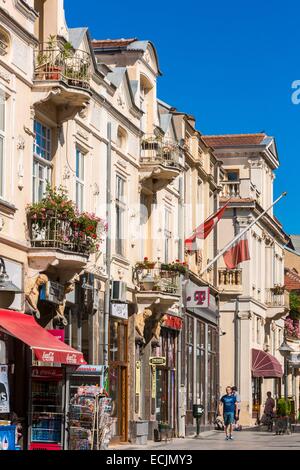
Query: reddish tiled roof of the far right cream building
202 134 267 148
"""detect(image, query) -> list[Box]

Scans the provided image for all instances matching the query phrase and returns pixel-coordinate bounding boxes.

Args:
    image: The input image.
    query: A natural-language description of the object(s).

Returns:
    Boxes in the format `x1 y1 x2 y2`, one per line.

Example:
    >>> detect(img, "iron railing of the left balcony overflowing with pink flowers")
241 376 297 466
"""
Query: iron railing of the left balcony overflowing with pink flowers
28 215 93 256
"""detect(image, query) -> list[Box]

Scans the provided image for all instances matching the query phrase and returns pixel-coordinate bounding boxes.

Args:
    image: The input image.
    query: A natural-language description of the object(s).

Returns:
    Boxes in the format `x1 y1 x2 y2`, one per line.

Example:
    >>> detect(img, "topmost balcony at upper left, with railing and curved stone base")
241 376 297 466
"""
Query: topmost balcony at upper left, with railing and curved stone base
33 40 91 121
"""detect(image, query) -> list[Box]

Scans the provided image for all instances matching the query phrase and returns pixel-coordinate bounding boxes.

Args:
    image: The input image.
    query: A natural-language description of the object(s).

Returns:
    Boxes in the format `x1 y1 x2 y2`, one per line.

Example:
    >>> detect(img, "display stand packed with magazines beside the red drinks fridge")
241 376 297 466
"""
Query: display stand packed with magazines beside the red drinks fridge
68 386 112 450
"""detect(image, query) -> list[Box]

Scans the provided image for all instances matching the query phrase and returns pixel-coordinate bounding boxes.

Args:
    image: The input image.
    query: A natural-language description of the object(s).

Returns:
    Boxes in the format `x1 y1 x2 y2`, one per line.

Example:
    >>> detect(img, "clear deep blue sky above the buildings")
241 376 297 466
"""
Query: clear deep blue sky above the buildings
65 0 300 234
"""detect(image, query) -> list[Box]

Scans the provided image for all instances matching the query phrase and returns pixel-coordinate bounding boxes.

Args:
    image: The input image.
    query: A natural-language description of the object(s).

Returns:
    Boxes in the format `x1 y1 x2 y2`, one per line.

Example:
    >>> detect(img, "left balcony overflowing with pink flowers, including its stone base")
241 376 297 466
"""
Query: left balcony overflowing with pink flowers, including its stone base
28 215 91 271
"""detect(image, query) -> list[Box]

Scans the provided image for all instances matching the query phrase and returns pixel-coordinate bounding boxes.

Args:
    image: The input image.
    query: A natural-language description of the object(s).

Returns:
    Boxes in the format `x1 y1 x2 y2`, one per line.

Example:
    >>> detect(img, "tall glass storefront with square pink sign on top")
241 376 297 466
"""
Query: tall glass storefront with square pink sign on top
181 281 219 435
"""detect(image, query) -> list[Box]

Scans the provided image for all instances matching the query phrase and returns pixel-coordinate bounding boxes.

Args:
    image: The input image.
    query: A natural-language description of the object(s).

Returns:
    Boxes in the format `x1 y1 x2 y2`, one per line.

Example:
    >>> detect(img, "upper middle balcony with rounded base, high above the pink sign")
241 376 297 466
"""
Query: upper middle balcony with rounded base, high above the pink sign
140 135 181 192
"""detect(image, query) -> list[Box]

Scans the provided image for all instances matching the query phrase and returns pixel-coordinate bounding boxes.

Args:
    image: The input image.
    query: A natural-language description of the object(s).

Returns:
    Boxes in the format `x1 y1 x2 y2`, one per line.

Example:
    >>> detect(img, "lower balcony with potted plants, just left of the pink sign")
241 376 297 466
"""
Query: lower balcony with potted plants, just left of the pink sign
133 263 183 308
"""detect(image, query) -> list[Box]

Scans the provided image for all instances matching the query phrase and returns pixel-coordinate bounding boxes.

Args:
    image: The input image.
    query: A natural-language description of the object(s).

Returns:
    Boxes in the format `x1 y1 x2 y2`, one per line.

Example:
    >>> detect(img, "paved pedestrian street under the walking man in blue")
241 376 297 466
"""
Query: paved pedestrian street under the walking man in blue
110 430 300 451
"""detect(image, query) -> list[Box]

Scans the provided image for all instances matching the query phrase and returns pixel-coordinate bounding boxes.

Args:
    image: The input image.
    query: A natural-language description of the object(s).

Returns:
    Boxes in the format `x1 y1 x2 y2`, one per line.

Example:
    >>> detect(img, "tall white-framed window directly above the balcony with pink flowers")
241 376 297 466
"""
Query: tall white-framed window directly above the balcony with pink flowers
32 120 52 202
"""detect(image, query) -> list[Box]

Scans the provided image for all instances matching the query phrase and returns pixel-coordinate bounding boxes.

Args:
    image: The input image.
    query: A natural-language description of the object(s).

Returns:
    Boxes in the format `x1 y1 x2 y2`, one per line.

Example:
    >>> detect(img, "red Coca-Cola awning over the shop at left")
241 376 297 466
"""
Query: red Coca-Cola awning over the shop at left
0 309 86 365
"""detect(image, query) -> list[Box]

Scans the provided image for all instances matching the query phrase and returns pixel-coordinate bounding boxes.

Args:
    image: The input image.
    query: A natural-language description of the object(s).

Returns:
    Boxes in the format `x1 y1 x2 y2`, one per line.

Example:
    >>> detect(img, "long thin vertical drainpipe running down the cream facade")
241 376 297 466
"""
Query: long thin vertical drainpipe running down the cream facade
103 122 112 367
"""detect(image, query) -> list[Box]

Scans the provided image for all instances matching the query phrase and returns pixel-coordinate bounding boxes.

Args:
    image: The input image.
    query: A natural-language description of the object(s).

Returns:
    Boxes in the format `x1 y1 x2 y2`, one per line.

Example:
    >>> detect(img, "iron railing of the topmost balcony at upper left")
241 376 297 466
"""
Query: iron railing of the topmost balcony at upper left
34 42 91 89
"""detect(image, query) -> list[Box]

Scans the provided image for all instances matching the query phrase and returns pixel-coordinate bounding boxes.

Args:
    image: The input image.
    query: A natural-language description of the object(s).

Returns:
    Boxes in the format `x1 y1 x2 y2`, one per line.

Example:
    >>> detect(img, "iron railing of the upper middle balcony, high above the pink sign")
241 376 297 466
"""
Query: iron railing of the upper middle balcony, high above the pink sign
141 134 181 168
